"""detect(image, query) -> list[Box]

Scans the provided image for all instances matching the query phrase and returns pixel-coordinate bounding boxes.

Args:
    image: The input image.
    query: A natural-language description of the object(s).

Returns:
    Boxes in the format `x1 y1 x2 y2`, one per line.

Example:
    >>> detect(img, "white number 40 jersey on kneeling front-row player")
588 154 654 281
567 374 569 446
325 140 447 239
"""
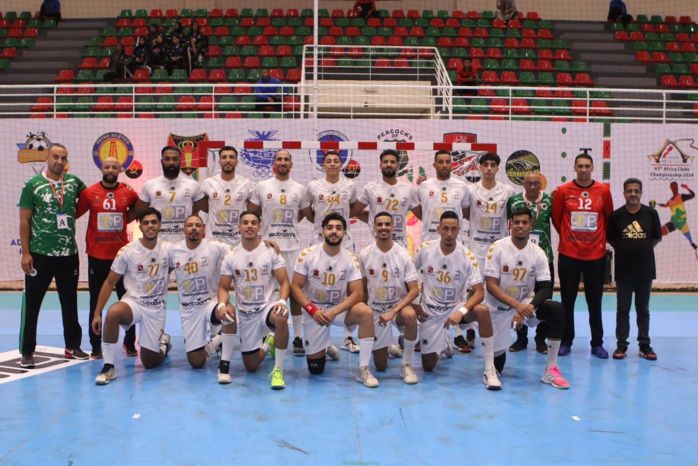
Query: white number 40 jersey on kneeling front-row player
169 239 230 311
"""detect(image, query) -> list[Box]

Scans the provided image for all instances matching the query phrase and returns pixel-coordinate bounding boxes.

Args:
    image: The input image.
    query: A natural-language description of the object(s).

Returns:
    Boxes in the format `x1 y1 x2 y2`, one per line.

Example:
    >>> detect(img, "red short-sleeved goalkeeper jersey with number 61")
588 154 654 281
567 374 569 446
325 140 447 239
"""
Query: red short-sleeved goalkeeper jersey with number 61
77 183 138 260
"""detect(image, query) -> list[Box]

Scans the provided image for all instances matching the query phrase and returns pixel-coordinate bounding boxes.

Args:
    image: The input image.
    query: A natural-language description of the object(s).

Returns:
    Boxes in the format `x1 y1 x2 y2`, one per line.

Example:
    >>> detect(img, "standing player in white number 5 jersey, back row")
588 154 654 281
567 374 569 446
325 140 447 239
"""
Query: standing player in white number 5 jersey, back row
414 150 471 353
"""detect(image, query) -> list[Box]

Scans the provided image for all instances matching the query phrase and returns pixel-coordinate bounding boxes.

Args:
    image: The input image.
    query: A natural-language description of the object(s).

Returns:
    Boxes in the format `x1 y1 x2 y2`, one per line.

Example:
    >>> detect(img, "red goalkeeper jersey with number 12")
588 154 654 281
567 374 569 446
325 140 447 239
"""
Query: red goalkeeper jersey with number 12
552 181 613 260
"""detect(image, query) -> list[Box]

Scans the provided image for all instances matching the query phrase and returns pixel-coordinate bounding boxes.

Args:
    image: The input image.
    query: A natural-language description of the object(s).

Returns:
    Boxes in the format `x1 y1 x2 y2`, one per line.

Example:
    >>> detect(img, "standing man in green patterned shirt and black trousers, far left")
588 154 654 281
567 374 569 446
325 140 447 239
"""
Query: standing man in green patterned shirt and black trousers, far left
19 144 89 368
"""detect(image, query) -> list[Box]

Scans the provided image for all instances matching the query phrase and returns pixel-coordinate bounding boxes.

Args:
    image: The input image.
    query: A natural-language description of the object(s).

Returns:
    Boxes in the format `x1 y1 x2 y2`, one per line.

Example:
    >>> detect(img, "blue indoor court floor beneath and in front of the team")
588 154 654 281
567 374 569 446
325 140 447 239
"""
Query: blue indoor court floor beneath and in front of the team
0 293 698 466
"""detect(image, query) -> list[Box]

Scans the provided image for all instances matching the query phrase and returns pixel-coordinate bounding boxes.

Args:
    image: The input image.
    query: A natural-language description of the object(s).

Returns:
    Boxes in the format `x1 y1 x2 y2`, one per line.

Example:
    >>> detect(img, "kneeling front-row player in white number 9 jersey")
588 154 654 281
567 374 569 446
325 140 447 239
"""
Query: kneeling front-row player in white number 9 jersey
359 212 419 384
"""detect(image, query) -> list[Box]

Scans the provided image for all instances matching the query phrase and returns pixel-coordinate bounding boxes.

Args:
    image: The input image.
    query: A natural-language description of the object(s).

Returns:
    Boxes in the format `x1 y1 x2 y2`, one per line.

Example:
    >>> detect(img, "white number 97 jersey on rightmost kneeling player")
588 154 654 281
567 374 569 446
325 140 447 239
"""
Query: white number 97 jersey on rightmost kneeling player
485 236 550 311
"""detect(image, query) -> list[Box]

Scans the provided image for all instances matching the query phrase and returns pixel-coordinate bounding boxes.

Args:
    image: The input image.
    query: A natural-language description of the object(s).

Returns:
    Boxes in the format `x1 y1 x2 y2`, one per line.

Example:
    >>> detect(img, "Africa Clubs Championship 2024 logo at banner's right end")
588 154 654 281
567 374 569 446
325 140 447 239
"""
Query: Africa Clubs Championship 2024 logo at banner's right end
647 138 698 180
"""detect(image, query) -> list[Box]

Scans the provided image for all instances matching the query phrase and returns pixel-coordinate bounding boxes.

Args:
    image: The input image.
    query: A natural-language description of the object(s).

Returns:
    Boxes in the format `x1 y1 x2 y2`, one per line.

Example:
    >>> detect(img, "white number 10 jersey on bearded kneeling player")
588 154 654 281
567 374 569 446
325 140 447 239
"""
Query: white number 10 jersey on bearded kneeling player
294 243 361 310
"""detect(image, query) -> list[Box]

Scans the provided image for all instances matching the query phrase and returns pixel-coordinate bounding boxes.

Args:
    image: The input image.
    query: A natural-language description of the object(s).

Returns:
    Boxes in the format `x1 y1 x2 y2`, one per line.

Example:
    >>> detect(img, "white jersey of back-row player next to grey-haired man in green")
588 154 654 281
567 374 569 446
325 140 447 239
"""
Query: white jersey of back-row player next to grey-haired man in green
468 182 516 266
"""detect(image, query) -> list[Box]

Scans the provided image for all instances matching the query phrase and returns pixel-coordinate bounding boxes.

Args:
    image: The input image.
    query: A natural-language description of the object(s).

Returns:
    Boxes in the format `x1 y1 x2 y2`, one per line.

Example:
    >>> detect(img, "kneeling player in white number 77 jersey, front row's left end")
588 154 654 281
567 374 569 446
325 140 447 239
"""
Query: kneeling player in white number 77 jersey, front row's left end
92 207 172 385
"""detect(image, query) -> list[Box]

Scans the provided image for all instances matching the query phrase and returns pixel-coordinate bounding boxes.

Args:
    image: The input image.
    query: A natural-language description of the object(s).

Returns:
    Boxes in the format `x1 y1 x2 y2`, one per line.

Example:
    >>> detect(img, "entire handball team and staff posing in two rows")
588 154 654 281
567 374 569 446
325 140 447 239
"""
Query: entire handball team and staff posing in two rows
18 144 656 391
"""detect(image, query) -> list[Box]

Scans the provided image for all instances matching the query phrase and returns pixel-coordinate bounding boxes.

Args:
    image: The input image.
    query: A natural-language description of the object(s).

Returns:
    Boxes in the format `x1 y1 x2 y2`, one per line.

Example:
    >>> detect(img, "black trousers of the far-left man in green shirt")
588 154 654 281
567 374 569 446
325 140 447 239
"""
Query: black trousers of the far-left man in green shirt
19 252 82 353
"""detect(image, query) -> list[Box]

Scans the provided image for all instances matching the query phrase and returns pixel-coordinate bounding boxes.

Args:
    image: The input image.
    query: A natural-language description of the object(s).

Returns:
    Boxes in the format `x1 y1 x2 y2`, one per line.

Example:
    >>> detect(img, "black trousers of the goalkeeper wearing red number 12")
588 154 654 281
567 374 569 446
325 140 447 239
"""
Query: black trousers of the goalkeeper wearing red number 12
557 254 606 347
